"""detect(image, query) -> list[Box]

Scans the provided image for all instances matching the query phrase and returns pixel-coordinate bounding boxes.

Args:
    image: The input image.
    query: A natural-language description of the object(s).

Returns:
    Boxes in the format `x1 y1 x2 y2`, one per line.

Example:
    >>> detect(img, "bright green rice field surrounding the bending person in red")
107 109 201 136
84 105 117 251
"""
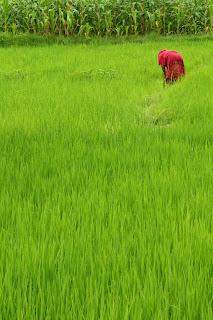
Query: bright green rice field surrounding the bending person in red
0 34 213 320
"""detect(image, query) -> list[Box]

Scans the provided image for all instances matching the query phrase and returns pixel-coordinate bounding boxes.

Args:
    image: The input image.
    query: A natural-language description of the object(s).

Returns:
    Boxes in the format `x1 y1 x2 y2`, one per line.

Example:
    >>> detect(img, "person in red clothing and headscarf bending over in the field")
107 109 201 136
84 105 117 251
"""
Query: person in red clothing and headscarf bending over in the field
158 50 185 83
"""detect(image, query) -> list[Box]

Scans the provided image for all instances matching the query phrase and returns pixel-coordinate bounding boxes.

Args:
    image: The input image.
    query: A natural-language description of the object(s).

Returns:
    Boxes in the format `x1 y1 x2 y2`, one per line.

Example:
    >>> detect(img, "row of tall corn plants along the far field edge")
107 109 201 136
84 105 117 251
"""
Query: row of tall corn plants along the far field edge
0 0 213 36
